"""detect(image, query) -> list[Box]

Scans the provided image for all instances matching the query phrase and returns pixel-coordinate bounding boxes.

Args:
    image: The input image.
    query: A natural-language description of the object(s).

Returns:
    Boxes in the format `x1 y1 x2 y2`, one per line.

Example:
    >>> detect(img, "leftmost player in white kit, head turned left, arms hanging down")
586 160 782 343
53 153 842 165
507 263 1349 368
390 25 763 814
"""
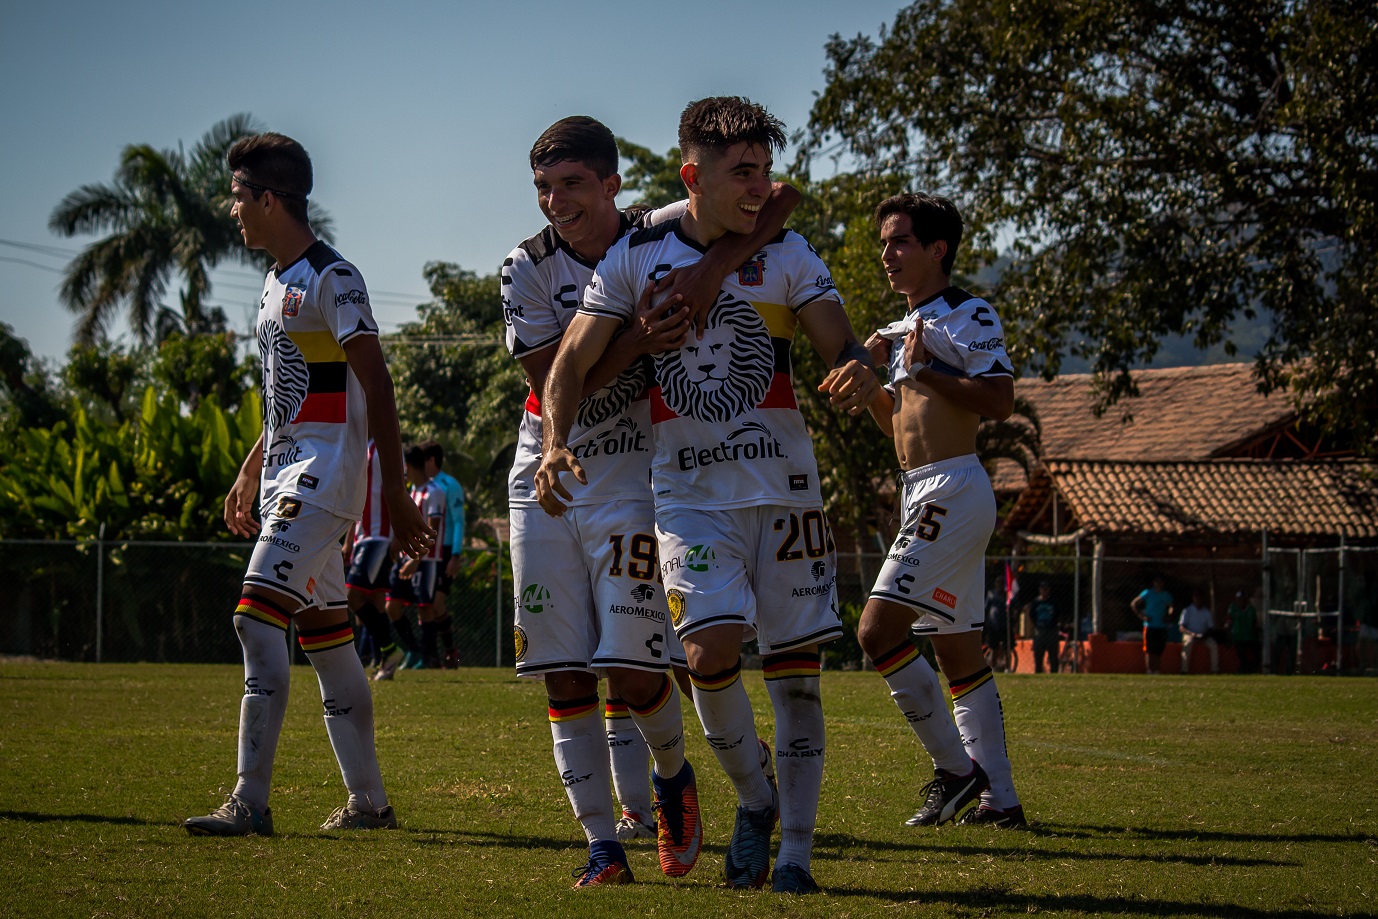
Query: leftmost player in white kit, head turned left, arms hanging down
183 134 434 836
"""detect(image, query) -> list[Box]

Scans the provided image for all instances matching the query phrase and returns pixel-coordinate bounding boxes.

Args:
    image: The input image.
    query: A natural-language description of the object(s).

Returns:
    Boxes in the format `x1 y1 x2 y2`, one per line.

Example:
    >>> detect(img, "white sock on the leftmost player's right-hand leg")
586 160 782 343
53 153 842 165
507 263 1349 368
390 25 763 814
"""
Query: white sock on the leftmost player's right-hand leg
298 623 387 812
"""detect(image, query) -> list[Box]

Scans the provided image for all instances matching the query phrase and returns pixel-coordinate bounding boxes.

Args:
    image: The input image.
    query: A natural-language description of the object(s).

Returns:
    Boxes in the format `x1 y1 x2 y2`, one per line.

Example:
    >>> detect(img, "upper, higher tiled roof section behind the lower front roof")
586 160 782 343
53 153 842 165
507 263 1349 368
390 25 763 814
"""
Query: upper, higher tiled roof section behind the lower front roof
1014 364 1293 462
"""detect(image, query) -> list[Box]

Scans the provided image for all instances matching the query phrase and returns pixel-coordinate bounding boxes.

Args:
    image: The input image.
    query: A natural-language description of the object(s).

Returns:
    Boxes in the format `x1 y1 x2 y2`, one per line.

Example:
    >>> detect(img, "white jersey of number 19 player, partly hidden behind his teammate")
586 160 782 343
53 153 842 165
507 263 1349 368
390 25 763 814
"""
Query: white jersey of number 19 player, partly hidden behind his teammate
502 212 659 507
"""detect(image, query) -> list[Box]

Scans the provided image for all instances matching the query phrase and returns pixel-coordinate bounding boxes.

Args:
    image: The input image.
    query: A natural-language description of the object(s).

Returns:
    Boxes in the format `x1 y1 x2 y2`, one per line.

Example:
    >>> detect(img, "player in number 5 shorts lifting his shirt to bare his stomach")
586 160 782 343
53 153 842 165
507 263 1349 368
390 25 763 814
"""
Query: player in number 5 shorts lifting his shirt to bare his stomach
819 194 1025 827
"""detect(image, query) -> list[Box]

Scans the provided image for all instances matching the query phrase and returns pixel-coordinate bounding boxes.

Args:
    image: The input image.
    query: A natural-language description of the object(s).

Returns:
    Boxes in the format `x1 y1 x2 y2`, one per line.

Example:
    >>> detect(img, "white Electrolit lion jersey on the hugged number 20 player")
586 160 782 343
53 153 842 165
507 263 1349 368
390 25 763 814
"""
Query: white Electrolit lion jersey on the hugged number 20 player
580 220 841 508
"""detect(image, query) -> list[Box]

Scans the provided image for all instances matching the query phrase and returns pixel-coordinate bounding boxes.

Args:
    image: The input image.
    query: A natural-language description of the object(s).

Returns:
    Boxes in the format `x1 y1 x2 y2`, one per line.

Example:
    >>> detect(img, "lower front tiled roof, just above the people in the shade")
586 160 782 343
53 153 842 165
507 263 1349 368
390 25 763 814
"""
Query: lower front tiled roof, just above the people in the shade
1005 459 1378 539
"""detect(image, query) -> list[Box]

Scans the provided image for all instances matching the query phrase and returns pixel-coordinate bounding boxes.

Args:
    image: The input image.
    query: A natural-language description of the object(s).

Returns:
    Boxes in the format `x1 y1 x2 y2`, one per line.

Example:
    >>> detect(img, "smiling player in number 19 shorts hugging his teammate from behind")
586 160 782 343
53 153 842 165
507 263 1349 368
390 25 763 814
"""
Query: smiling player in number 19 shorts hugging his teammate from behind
502 116 796 887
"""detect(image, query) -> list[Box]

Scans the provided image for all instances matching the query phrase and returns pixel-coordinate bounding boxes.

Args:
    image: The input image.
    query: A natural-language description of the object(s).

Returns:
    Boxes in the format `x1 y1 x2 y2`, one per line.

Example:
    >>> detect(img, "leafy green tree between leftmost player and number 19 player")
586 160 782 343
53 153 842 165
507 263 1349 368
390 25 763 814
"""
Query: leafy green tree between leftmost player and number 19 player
383 262 526 521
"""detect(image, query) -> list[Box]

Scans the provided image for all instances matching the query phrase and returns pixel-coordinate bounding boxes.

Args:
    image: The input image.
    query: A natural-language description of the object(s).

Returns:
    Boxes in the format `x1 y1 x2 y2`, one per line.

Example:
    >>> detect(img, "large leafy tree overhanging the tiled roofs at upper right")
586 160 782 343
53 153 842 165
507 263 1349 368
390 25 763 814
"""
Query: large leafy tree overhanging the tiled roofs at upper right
805 0 1378 452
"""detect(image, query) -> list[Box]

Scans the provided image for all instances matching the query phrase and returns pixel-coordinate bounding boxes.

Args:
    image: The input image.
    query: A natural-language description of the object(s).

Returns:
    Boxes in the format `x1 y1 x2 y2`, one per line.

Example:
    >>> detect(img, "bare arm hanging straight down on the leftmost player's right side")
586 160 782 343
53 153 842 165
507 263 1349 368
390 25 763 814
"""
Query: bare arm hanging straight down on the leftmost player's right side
343 335 435 558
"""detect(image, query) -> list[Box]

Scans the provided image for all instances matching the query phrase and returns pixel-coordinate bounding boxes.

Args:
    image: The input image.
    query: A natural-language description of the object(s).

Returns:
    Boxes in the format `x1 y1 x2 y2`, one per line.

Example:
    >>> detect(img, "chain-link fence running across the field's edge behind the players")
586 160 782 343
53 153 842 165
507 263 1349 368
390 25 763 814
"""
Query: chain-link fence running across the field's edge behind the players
0 540 1378 672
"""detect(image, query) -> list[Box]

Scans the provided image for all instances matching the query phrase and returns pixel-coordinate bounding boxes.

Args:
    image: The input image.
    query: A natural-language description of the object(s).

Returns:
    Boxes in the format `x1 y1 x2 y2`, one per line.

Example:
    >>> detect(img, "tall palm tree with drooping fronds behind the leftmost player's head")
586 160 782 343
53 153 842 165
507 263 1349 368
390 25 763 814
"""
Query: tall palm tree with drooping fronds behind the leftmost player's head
48 114 329 344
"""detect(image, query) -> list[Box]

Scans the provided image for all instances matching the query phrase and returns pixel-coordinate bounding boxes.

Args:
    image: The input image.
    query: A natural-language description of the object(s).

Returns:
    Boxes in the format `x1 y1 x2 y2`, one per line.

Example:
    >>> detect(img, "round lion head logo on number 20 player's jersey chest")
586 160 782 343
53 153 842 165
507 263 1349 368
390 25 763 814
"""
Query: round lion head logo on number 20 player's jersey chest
655 295 774 423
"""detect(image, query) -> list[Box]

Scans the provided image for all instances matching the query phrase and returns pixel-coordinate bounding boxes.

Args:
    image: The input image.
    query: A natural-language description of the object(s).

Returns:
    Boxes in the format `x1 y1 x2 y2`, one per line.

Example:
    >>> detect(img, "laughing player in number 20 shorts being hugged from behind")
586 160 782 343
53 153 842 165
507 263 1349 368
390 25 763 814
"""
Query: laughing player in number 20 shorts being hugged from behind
536 96 878 893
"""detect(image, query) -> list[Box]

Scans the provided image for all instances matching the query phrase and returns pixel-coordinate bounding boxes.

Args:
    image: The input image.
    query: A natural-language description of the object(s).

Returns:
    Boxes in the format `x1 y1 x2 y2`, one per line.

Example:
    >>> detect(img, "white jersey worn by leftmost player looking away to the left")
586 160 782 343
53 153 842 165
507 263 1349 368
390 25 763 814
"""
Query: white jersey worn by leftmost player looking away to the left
258 241 378 519
